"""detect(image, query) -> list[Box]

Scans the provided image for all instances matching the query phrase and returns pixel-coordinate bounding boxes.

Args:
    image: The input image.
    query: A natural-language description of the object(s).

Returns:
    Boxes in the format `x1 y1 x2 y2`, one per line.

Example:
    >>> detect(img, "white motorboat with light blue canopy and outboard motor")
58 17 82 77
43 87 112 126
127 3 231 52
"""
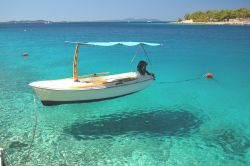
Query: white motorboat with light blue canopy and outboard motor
29 42 160 106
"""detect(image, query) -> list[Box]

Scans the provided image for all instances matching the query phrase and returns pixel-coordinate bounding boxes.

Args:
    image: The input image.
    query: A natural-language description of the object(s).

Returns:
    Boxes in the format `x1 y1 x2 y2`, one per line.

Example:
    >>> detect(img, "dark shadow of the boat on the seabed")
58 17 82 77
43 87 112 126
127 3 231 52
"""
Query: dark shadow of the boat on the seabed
63 110 201 140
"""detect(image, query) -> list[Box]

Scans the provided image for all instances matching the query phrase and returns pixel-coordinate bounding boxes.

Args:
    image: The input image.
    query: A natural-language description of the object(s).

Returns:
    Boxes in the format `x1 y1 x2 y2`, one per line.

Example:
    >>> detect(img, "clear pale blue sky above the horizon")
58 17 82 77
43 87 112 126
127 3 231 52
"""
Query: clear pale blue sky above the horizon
0 0 250 22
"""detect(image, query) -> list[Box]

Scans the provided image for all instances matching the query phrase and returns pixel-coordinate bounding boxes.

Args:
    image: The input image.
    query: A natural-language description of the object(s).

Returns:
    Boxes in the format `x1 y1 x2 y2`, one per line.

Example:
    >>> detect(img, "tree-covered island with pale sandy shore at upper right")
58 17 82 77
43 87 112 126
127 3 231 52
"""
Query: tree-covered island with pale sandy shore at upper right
175 8 250 25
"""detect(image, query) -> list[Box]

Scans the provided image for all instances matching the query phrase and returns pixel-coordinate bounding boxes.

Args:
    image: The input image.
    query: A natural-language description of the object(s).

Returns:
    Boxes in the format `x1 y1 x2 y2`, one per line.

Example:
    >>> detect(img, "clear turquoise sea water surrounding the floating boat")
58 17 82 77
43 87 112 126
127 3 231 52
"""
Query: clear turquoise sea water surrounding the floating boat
0 23 250 166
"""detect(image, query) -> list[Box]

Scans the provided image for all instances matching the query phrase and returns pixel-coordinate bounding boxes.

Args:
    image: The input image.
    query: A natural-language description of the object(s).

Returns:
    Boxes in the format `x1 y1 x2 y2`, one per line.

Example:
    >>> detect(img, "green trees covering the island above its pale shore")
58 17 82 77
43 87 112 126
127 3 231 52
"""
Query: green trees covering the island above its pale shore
184 8 250 22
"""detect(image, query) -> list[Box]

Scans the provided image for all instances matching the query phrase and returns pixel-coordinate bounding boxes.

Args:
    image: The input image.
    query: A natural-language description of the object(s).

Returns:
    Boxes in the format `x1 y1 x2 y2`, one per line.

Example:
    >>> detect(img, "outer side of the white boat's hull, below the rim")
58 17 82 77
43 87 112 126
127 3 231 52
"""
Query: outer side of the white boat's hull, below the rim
33 79 153 106
